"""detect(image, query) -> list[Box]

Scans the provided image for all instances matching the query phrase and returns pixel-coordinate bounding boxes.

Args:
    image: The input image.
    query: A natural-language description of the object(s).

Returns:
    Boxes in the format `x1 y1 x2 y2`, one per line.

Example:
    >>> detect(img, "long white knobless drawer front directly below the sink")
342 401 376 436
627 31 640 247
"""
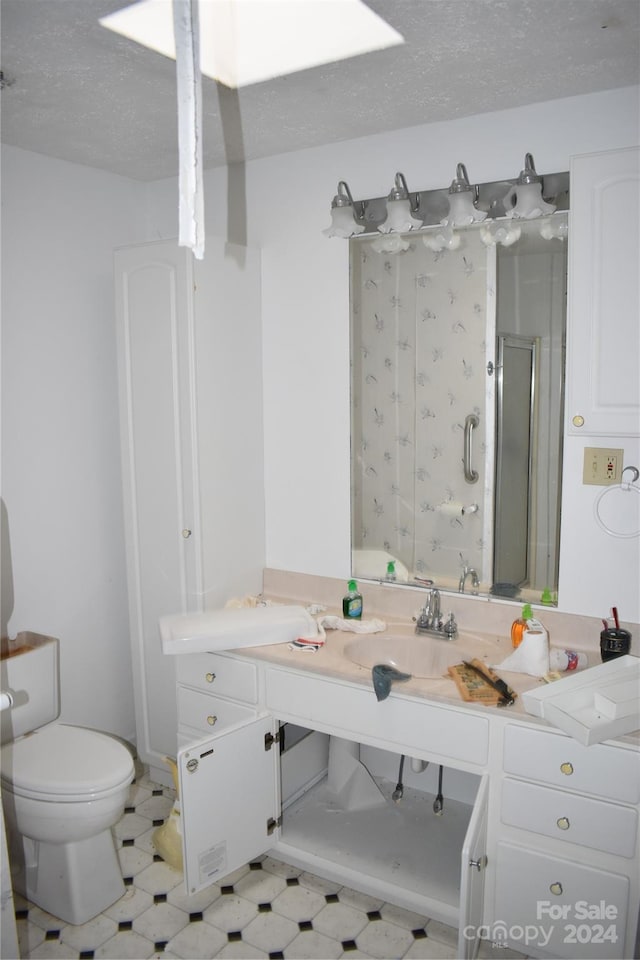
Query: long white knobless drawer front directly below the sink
266 670 489 766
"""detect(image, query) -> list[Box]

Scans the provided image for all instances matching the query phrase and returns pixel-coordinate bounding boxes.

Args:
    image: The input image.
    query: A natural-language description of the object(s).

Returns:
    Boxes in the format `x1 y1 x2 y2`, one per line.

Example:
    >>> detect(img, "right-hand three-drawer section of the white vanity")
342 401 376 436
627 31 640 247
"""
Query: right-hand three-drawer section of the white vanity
494 724 640 960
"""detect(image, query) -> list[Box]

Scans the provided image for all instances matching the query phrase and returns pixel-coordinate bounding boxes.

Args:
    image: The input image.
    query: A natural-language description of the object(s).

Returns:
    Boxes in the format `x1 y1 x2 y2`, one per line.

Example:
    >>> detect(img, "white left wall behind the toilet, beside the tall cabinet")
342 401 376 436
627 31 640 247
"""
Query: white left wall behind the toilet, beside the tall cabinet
2 148 141 739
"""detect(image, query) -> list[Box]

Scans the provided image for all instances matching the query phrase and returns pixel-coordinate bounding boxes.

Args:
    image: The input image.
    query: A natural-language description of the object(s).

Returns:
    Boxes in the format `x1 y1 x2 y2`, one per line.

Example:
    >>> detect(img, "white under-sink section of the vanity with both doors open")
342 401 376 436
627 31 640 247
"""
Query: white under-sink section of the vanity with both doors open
178 654 488 958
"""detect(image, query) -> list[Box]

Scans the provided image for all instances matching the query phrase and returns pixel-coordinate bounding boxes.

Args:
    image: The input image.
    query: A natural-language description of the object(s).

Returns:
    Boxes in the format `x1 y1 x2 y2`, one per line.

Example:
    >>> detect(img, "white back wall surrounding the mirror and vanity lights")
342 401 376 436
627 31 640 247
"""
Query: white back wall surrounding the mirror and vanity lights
162 88 640 621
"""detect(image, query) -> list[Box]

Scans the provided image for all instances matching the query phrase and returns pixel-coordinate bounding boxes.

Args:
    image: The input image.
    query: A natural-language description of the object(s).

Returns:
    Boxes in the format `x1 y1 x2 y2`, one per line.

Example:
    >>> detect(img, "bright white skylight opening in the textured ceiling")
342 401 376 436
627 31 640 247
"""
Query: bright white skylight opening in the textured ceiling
100 0 404 87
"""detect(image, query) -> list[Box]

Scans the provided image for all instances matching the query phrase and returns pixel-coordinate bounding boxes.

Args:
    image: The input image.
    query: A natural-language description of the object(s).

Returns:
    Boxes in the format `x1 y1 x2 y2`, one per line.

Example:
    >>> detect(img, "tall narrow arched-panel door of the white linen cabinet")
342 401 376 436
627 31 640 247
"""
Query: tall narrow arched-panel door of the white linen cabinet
115 242 202 766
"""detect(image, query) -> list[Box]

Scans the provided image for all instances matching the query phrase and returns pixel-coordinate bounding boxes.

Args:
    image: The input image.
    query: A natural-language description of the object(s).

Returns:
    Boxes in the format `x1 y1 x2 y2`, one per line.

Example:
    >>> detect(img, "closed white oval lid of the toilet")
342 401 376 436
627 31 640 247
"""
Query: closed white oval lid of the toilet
2 723 134 802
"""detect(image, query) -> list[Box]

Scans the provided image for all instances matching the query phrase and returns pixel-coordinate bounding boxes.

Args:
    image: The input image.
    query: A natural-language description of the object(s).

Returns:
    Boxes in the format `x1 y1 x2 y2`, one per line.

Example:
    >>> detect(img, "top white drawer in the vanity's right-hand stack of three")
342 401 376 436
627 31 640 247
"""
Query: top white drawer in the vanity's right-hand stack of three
504 724 640 803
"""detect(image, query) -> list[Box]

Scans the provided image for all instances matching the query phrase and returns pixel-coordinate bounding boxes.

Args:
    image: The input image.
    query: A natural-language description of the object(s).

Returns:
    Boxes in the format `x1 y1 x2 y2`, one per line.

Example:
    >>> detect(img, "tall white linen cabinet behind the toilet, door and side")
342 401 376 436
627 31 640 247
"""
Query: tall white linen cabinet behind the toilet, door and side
115 238 264 778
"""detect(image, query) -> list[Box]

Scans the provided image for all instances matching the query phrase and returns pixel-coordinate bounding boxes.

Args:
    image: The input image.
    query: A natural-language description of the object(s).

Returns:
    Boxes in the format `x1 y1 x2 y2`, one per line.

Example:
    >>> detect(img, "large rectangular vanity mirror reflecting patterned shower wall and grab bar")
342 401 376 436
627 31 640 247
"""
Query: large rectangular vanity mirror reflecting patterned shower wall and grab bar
349 213 567 602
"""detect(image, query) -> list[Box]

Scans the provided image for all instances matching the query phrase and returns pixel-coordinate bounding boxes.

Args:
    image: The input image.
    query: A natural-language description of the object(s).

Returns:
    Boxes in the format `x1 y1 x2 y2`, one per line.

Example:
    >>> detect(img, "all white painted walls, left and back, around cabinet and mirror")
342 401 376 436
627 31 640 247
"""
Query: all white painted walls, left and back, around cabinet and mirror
2 89 640 737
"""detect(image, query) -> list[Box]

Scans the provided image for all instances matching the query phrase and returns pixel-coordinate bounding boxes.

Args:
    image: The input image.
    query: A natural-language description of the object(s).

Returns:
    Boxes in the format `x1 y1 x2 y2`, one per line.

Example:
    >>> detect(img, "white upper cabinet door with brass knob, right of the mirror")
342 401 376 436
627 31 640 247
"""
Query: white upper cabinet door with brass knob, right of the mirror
566 147 640 436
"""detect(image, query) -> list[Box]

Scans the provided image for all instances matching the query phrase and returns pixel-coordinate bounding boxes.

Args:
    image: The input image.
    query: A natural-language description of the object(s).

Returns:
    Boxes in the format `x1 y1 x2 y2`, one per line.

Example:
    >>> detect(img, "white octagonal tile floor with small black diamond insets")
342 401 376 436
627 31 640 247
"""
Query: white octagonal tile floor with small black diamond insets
10 773 520 960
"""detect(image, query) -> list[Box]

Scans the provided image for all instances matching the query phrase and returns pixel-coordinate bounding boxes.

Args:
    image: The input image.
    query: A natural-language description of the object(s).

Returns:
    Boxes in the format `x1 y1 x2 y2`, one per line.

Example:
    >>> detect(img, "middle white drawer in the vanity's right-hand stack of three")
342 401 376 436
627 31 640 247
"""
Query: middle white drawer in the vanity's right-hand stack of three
500 779 638 857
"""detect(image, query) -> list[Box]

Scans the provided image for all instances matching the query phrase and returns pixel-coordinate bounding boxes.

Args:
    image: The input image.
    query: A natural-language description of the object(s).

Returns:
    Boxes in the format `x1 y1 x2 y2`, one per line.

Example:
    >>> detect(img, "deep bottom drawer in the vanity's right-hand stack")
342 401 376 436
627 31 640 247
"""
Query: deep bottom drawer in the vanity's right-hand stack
493 843 632 960
